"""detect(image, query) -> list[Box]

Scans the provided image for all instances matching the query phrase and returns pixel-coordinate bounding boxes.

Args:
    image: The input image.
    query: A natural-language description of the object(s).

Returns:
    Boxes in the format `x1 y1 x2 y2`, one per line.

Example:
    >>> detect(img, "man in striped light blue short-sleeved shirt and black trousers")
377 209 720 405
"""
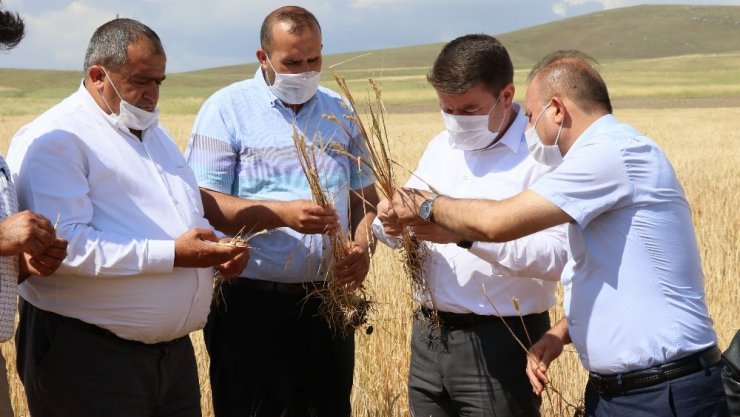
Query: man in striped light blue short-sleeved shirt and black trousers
186 7 378 417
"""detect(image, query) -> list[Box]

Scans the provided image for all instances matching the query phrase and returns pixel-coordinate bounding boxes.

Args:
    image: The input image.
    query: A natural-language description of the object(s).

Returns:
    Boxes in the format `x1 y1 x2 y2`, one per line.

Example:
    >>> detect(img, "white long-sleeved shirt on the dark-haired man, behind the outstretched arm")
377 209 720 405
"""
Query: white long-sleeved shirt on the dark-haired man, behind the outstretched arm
373 105 567 316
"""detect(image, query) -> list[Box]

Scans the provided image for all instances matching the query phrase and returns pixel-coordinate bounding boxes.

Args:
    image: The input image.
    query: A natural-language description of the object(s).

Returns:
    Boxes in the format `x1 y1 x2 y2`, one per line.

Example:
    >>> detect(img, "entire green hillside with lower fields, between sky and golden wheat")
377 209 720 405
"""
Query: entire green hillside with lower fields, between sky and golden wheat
0 5 740 114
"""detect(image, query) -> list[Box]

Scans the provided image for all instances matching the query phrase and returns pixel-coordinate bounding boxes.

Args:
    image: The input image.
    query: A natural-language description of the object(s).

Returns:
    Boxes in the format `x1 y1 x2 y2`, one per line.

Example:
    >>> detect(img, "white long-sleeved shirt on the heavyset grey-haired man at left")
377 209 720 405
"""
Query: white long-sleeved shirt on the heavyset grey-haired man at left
8 80 213 343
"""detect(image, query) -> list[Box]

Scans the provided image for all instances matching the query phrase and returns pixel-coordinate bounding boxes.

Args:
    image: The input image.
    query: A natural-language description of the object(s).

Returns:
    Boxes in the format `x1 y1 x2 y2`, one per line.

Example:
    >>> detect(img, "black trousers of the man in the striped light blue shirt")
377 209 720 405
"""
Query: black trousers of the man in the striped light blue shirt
204 278 354 417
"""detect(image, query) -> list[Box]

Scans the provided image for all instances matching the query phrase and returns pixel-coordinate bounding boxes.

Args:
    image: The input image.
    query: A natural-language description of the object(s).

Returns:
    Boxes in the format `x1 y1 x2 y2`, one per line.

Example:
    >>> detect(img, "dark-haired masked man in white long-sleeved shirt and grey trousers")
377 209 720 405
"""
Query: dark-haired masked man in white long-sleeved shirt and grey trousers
374 35 567 417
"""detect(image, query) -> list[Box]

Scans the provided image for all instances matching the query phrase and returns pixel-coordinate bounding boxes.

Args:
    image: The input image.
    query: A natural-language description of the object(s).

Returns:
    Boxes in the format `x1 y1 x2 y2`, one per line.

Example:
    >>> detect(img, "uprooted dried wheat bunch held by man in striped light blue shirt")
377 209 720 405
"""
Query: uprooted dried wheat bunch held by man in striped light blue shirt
293 126 373 336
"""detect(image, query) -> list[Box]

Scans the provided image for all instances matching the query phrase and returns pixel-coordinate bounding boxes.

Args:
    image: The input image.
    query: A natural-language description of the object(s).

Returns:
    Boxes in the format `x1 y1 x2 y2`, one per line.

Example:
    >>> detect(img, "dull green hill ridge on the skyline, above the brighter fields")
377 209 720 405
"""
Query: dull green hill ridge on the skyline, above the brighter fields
186 5 740 75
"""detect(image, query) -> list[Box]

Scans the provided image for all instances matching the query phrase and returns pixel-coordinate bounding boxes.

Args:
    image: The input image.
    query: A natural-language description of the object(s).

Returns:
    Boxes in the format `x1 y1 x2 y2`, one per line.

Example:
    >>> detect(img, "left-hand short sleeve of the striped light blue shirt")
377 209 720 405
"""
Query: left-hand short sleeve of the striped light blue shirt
185 96 238 194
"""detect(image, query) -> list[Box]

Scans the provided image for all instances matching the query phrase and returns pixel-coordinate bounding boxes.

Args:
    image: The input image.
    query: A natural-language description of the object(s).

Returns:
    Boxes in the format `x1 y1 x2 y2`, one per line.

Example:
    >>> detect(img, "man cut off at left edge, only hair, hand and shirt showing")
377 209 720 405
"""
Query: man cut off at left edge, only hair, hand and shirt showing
0 4 67 417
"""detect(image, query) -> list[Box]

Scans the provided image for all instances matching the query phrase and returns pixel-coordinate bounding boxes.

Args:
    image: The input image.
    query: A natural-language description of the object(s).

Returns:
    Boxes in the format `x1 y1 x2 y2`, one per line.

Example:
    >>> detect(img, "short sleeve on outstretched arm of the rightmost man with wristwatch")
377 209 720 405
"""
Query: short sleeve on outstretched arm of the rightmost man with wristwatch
530 139 631 228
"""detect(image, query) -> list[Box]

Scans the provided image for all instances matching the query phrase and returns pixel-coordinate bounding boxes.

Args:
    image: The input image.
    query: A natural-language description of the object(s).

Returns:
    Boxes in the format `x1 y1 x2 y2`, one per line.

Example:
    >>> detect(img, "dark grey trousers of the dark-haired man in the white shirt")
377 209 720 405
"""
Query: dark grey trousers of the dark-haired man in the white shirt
409 312 550 417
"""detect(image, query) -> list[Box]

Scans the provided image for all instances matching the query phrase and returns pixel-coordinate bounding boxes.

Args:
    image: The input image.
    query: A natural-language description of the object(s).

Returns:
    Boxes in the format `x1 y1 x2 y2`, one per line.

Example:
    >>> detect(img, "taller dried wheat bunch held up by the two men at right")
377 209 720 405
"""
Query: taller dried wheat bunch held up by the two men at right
324 73 438 316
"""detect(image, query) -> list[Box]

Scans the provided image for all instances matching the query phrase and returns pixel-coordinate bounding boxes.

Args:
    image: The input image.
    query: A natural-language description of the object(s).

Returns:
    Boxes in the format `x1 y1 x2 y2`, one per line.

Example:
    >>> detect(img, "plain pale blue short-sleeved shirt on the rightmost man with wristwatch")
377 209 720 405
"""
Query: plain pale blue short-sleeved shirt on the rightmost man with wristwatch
532 115 717 374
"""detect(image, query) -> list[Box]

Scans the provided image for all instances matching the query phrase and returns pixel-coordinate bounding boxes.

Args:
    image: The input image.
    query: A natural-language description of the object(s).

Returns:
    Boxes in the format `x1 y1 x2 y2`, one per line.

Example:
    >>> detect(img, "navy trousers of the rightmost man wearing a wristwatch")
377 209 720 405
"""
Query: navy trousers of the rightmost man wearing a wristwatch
585 362 730 417
